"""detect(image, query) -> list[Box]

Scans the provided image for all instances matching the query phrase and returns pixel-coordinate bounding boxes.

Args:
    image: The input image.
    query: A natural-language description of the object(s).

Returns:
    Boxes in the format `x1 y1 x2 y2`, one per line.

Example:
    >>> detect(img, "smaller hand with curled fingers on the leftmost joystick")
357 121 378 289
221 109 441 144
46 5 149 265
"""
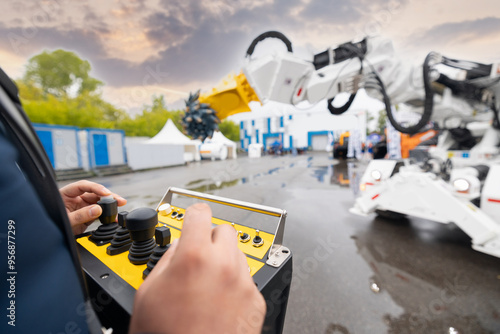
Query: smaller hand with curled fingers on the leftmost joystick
59 180 127 235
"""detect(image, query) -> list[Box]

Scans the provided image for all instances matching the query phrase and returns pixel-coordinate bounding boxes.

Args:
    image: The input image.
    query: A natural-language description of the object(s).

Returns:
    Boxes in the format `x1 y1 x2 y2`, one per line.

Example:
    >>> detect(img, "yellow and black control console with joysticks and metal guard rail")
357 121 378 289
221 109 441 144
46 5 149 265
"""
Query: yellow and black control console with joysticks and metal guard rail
77 187 292 333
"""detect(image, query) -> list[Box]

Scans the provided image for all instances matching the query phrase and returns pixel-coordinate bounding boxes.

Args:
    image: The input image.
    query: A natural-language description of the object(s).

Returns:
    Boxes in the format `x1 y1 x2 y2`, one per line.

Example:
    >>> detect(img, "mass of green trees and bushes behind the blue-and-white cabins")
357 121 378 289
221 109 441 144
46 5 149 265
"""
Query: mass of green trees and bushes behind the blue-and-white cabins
17 50 191 137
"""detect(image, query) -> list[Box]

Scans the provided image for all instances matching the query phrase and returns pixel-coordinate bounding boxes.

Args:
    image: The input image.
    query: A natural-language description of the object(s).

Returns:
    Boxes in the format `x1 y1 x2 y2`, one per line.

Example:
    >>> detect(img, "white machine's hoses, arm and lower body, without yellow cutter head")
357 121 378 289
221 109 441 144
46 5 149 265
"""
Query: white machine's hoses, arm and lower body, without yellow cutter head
243 34 500 257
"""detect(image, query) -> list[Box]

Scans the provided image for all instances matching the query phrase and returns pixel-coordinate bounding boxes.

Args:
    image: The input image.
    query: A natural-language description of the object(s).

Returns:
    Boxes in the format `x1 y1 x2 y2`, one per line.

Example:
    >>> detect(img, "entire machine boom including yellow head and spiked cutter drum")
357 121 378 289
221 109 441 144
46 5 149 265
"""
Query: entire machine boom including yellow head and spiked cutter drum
184 31 500 147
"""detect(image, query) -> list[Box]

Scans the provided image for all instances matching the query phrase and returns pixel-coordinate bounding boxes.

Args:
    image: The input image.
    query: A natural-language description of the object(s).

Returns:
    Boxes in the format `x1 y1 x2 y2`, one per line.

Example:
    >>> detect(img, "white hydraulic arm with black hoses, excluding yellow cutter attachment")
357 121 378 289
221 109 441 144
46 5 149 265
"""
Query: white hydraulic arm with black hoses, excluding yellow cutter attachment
243 32 500 151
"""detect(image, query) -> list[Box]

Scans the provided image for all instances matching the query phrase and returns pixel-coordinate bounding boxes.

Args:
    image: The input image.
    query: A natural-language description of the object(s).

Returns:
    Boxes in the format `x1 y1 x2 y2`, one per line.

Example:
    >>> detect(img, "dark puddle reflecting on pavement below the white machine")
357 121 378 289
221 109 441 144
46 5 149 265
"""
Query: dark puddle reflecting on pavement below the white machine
352 218 500 333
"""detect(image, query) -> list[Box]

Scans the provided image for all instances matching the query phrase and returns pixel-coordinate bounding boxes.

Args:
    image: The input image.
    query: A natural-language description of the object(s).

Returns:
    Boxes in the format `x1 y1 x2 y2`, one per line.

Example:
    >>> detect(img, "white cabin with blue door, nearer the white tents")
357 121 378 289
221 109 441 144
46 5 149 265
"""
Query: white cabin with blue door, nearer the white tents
80 128 127 170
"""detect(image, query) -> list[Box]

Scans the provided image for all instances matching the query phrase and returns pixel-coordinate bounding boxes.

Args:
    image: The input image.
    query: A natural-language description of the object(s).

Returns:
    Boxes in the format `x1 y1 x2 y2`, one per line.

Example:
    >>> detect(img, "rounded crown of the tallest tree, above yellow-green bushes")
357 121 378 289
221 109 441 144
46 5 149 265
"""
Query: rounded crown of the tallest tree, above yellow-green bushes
24 49 103 97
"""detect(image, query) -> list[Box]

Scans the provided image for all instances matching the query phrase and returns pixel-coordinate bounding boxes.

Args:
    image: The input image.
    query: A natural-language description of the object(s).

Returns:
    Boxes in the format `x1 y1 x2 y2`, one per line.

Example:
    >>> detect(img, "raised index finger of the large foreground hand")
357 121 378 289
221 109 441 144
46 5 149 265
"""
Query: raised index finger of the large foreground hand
179 203 212 247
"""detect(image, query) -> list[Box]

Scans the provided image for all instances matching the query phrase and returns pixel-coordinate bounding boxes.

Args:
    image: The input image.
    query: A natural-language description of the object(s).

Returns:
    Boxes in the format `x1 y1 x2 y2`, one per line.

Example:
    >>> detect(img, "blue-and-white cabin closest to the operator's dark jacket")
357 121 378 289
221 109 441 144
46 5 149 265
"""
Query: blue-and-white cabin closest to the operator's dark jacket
33 124 83 172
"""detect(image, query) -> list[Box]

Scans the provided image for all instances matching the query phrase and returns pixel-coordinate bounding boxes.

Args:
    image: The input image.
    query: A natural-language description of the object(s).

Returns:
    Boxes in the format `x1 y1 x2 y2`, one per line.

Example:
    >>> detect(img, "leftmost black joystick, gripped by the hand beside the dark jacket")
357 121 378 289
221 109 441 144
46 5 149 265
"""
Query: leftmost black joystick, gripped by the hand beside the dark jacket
89 196 118 246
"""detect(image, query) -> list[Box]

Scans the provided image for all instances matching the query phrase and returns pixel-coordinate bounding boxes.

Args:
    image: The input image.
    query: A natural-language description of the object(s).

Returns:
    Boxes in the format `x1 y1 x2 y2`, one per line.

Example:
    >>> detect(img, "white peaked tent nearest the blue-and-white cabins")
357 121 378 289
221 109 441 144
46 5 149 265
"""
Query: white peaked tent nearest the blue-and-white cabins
146 119 201 161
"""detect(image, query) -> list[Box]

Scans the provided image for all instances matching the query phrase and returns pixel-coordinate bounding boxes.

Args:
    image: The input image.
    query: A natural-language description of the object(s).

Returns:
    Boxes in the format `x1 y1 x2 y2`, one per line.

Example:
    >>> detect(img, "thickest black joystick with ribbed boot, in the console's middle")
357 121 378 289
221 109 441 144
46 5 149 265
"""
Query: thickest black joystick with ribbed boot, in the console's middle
126 208 158 264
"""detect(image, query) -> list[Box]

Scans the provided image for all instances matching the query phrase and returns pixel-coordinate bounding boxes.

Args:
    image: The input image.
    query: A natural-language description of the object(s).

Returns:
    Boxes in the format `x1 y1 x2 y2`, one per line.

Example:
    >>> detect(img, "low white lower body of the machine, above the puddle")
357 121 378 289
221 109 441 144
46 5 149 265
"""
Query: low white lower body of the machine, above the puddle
350 160 500 257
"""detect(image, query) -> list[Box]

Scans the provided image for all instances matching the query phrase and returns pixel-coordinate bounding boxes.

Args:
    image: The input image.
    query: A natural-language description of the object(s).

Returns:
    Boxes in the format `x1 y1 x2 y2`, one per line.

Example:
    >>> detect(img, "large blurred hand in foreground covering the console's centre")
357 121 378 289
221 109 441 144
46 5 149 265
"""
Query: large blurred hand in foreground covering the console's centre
130 204 266 334
